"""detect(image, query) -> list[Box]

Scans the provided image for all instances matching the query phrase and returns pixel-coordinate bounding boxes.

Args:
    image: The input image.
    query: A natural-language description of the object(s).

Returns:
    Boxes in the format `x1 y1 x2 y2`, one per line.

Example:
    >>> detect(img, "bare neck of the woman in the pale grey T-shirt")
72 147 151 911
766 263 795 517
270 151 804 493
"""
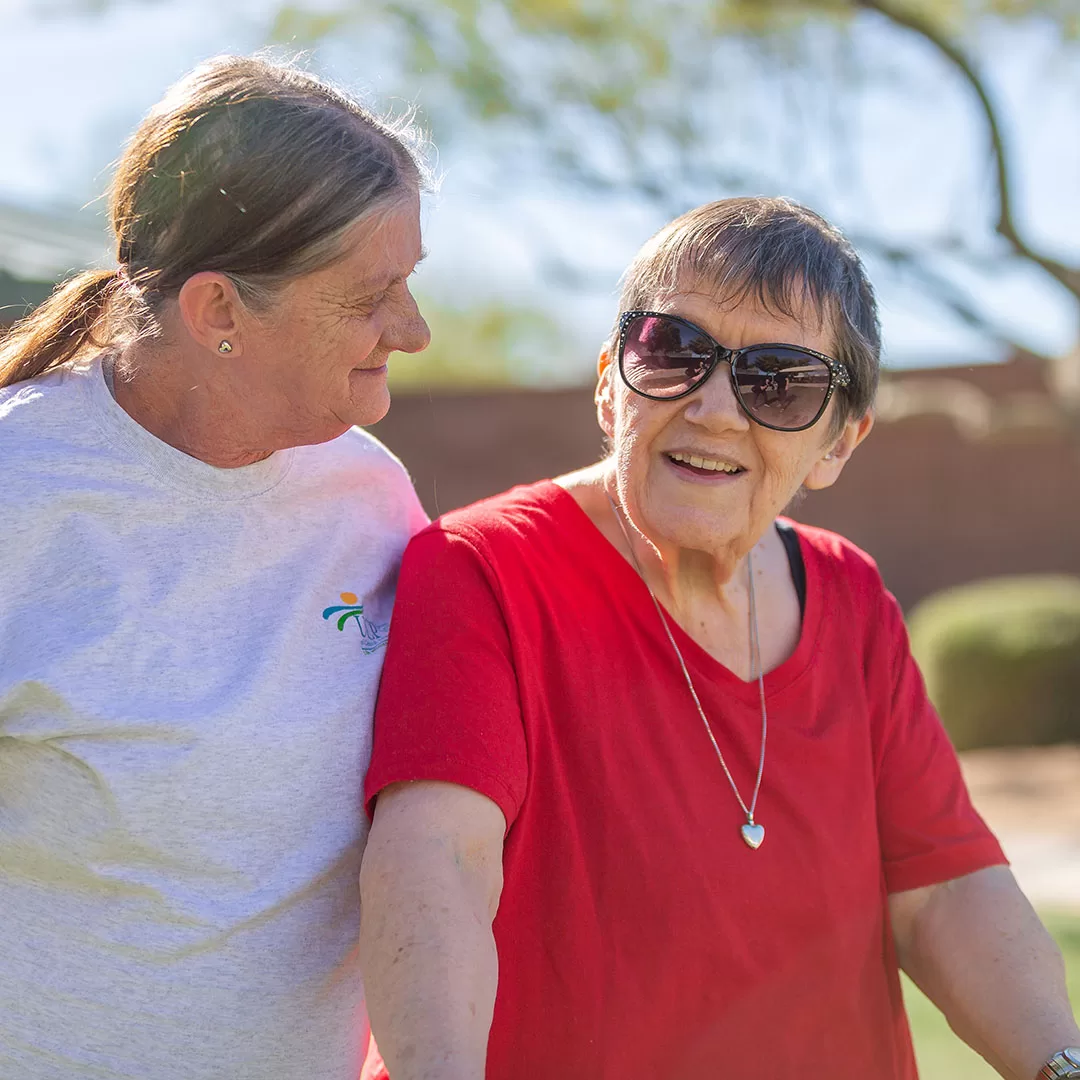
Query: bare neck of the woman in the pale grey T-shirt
113 341 279 469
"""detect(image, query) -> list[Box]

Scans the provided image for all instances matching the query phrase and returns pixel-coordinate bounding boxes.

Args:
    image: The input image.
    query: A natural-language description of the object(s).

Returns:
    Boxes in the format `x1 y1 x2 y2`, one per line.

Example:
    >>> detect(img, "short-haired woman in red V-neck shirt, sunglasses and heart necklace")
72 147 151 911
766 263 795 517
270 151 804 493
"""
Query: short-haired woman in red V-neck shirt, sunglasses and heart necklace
361 199 1080 1080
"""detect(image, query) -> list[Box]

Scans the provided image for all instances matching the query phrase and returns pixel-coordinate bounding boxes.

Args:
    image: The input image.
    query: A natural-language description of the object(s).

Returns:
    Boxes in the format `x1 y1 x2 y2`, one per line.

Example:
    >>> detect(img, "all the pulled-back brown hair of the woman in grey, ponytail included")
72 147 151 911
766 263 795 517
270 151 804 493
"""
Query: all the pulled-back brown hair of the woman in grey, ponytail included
0 56 427 389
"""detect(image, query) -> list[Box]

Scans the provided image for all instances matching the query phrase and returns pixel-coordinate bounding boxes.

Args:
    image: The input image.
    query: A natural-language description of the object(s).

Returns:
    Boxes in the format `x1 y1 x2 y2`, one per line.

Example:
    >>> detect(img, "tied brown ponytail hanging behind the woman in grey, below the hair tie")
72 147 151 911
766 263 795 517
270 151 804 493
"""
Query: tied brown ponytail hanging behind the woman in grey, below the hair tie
0 270 131 390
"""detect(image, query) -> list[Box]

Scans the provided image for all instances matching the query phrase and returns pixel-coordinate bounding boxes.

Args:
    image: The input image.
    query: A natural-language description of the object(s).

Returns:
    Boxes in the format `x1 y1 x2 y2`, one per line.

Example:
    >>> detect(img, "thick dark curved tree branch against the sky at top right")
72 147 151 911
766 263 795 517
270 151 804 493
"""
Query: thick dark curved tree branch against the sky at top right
853 0 1080 300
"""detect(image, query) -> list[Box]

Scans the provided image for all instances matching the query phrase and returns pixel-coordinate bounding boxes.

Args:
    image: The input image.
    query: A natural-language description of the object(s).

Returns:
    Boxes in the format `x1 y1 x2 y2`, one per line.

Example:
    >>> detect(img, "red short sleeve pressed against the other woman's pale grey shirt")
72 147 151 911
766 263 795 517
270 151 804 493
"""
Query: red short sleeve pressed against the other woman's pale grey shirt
364 525 528 828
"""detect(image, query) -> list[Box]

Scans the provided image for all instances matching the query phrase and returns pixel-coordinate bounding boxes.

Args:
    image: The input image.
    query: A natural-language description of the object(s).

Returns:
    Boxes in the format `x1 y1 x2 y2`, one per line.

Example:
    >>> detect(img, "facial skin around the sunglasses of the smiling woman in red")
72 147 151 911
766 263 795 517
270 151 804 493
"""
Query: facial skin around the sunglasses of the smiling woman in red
602 293 836 553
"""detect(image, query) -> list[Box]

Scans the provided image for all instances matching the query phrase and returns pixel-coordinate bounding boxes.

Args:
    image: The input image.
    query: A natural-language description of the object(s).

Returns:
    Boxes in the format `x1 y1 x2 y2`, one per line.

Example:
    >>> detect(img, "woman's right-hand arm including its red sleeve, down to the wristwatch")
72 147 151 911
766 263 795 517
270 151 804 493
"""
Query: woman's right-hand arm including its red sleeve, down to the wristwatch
877 587 1078 1080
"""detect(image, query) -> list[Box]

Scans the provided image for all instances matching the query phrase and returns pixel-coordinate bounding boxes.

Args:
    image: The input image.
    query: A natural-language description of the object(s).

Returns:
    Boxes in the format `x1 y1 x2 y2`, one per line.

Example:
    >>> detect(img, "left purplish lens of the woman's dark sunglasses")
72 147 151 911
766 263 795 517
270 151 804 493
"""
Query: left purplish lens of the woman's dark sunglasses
622 315 714 397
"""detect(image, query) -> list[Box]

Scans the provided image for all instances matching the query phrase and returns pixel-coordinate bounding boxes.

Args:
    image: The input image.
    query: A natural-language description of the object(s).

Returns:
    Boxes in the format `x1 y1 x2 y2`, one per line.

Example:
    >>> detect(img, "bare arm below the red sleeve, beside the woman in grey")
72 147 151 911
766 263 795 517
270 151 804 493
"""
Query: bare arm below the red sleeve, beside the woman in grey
360 781 505 1080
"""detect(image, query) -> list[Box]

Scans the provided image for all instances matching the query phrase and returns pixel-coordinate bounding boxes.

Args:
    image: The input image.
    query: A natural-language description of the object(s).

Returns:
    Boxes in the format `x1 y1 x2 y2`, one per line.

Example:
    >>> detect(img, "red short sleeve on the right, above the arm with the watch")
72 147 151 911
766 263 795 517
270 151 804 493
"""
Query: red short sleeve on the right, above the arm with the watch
877 594 1007 892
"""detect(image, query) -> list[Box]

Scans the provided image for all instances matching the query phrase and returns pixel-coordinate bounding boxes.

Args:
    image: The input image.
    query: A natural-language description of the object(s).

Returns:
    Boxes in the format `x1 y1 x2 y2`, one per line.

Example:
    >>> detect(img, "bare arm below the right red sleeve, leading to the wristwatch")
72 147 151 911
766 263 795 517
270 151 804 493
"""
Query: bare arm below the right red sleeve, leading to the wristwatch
889 866 1080 1080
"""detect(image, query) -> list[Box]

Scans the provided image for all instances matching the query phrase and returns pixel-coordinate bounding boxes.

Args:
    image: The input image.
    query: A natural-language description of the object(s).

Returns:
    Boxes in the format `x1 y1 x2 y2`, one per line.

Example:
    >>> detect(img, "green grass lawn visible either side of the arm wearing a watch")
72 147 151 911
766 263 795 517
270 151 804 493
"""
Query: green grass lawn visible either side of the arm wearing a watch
904 912 1080 1080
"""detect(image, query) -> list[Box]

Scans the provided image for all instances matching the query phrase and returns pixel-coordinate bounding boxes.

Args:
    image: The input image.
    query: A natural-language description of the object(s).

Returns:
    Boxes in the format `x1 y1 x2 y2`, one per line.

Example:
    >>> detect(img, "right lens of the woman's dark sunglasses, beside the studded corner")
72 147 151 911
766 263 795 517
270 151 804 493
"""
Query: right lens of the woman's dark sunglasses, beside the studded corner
734 346 829 431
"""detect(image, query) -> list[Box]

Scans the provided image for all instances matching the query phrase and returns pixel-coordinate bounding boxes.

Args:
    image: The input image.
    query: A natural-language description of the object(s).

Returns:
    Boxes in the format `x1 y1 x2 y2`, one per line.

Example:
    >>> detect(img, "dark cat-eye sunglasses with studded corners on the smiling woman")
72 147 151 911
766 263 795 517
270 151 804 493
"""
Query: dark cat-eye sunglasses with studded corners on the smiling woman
618 311 851 431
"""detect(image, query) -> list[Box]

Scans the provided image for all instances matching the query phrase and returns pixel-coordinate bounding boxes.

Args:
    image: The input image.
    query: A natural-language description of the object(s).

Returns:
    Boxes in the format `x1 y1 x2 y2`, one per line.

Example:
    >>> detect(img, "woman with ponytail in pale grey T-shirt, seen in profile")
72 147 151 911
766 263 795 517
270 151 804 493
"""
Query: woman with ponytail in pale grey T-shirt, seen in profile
0 57 428 1080
